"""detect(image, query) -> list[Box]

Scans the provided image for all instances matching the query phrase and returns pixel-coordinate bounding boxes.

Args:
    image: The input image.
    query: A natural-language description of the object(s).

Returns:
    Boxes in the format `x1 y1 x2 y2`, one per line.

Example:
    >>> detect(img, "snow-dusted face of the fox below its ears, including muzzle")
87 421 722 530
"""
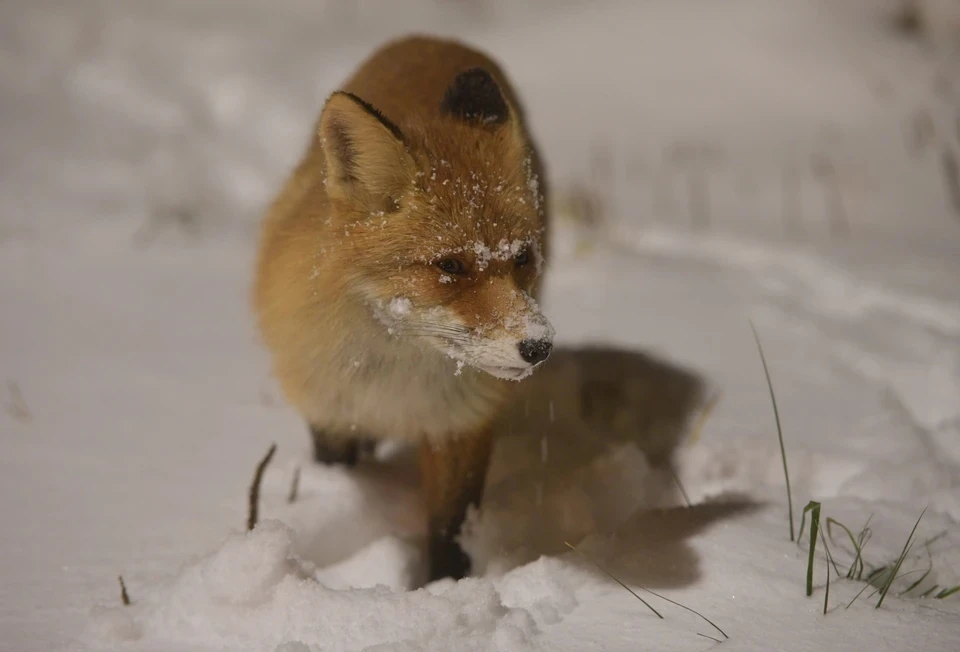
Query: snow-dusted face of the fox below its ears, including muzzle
351 158 554 380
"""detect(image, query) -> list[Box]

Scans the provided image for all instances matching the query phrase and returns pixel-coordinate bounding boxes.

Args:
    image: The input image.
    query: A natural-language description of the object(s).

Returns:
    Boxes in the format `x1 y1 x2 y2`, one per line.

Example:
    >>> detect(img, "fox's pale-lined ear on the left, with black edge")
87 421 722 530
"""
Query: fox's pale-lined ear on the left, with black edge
319 91 416 212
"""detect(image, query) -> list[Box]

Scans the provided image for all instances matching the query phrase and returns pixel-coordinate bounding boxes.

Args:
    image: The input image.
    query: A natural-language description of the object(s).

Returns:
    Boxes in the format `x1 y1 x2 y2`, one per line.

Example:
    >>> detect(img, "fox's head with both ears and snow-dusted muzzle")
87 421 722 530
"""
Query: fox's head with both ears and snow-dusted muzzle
319 68 553 380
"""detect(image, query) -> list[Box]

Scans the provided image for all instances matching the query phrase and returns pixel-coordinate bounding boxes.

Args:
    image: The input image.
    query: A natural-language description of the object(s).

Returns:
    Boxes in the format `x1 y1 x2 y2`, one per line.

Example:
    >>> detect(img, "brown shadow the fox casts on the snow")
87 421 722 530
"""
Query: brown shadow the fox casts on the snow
284 346 749 588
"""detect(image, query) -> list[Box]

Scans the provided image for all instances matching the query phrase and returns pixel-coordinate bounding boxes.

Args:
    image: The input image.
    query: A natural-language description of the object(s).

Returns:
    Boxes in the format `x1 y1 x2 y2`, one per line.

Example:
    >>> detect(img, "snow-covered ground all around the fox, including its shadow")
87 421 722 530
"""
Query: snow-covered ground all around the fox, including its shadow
0 0 960 652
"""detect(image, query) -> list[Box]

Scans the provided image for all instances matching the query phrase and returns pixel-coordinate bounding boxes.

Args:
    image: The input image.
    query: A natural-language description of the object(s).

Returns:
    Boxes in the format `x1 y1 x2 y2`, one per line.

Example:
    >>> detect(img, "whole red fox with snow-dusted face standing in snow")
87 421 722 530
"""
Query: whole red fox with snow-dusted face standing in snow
254 36 554 580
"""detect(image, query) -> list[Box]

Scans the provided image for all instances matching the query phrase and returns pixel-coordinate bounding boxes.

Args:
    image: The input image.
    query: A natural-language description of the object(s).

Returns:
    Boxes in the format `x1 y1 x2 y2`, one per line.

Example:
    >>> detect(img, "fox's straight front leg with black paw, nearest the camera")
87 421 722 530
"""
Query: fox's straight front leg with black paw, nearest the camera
420 431 492 581
